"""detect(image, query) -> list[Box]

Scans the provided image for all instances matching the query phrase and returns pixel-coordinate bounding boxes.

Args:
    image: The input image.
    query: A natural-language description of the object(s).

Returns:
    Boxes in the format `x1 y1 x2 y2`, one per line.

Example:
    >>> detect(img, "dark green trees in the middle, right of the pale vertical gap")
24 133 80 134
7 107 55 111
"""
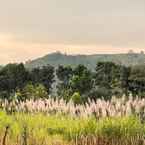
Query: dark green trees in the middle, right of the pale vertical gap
56 65 93 98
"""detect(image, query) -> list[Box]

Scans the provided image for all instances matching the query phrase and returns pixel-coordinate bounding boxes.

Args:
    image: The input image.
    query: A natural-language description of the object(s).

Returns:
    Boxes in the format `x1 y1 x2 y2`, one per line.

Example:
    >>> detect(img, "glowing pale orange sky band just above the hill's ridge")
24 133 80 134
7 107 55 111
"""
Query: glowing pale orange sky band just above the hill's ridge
0 34 145 64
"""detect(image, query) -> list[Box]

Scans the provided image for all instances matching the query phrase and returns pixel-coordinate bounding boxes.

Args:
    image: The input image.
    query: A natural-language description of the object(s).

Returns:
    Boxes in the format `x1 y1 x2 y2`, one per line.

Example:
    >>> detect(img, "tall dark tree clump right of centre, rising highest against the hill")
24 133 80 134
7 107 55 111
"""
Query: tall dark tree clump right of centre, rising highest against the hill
93 62 130 99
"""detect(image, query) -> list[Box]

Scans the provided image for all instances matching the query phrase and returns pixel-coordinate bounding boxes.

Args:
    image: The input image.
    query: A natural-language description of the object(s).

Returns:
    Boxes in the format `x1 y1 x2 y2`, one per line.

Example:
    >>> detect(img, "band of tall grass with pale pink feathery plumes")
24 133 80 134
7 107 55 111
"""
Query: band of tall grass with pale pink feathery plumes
0 96 145 121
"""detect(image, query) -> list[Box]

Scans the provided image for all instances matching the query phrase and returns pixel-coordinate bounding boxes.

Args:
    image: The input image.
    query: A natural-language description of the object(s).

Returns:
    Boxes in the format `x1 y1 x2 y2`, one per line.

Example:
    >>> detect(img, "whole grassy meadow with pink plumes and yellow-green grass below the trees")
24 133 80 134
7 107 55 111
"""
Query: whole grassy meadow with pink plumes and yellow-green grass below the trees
0 96 145 145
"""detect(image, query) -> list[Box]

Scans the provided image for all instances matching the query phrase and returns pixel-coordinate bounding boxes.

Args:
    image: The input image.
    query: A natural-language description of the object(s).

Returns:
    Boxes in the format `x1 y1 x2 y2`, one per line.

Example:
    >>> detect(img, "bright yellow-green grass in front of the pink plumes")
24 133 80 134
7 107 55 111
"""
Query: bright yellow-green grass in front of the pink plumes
0 111 145 145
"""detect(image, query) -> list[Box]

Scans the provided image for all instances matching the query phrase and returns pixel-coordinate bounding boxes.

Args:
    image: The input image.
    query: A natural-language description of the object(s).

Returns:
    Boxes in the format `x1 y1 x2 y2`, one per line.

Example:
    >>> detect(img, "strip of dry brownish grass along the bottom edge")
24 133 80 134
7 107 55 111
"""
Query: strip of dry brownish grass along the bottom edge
0 135 145 145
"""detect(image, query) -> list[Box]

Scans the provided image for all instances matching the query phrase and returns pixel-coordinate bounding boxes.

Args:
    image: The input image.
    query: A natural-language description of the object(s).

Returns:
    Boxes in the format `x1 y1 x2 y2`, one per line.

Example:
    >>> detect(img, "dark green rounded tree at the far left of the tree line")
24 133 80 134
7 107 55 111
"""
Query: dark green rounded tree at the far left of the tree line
0 63 28 99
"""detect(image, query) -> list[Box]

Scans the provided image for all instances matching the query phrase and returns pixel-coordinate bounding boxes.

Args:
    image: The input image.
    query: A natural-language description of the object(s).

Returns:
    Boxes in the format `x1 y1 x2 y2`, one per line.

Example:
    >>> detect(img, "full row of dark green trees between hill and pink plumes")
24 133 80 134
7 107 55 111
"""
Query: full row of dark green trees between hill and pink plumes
0 62 145 103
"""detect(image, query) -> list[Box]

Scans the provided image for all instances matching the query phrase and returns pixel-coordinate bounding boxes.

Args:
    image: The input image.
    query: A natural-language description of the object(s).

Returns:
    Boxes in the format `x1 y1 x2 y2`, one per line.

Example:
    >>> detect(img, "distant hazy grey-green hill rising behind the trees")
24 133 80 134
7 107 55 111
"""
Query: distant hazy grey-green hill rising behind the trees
25 52 145 69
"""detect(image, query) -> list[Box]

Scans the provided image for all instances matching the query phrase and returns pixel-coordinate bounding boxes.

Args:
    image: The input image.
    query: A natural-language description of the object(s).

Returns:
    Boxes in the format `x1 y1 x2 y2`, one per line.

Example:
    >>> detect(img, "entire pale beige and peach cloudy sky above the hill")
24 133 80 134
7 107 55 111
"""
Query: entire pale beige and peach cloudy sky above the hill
0 0 145 64
